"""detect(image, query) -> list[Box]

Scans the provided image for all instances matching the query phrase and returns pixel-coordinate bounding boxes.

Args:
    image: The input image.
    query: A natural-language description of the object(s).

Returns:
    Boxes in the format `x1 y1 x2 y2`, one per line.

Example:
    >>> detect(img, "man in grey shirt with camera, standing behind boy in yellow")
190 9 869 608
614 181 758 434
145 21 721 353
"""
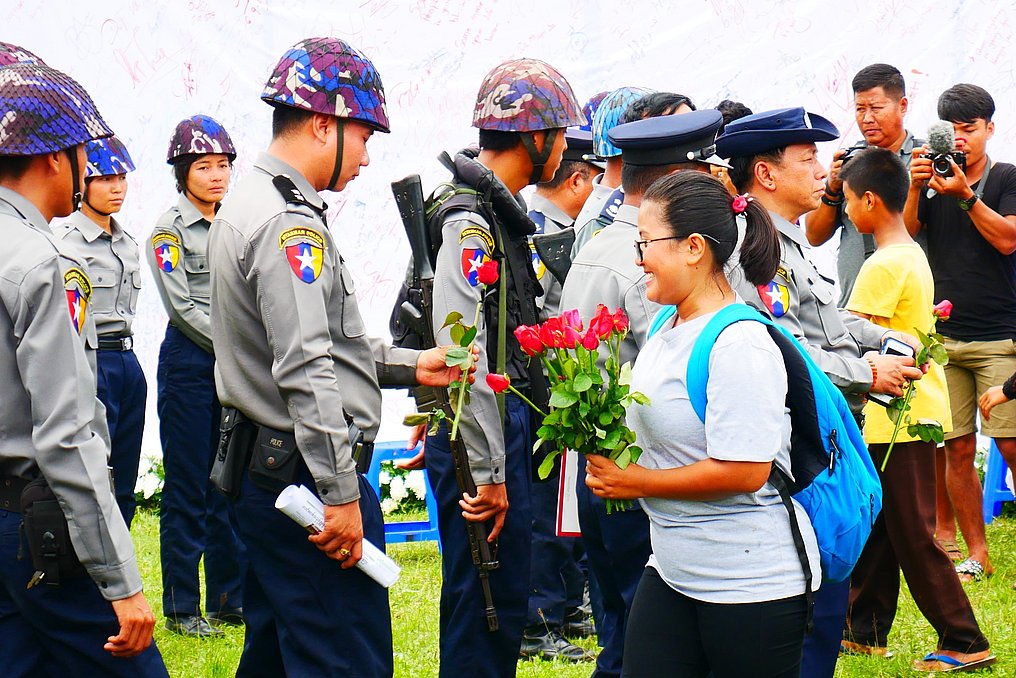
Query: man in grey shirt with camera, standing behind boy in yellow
805 64 925 308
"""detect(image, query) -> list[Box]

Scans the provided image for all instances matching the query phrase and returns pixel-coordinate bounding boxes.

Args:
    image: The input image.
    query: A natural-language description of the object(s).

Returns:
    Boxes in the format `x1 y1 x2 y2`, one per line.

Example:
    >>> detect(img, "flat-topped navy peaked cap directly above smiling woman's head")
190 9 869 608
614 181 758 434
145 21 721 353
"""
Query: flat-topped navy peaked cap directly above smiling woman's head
607 109 729 167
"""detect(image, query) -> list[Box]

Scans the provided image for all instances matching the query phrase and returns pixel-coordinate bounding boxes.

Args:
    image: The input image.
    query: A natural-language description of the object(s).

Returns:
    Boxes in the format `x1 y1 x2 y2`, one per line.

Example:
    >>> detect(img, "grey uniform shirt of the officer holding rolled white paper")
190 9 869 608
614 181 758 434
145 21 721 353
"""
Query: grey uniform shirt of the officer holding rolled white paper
208 153 419 504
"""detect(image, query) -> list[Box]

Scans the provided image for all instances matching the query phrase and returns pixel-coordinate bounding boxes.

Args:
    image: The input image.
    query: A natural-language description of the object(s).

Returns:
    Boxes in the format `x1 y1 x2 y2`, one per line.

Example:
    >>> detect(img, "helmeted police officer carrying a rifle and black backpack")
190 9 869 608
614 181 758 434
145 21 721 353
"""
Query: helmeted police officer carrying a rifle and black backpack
426 59 583 677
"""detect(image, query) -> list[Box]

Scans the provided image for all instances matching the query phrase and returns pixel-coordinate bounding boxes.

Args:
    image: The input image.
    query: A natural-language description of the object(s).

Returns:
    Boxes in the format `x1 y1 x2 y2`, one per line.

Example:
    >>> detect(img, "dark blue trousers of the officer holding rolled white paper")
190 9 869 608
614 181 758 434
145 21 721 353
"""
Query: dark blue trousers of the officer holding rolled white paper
233 467 393 678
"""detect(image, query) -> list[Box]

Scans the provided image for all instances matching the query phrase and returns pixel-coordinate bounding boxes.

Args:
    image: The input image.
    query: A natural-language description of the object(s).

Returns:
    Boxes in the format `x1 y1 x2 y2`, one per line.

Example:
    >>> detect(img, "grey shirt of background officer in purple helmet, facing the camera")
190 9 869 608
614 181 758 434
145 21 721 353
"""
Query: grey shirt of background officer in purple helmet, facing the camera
147 194 212 353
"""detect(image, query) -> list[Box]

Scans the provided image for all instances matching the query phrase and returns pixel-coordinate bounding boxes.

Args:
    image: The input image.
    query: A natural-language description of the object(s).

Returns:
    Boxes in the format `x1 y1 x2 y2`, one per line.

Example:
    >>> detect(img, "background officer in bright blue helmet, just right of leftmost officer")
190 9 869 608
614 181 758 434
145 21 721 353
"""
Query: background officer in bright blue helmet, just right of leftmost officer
57 136 148 528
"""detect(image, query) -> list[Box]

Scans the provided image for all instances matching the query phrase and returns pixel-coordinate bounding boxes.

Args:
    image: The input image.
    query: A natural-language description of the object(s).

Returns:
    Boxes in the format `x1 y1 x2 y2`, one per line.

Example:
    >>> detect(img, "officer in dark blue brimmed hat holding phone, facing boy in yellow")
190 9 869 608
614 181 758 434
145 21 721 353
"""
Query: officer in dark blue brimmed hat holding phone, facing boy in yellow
716 108 922 678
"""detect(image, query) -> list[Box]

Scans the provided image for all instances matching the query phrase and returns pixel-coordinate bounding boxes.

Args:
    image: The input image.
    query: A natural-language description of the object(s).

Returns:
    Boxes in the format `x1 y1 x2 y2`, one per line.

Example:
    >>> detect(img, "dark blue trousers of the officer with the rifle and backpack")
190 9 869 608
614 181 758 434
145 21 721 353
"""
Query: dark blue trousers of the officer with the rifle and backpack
426 395 532 678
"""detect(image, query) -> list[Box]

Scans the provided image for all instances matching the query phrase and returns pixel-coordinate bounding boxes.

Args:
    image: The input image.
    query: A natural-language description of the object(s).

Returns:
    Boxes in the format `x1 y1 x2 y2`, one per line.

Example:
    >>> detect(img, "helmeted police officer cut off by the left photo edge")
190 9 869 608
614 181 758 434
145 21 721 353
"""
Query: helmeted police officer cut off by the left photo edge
0 63 168 677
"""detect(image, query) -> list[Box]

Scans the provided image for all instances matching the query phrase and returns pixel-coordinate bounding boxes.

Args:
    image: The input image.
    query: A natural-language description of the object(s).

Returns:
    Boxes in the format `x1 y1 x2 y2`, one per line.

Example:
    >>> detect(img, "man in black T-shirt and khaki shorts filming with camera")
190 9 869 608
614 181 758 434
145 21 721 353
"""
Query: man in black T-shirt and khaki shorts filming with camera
904 83 1016 580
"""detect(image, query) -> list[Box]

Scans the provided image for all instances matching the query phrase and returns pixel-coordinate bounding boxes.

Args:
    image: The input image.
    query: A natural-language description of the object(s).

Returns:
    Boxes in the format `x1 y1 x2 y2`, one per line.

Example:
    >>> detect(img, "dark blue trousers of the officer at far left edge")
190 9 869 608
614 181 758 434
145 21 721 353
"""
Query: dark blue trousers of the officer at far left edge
0 510 169 678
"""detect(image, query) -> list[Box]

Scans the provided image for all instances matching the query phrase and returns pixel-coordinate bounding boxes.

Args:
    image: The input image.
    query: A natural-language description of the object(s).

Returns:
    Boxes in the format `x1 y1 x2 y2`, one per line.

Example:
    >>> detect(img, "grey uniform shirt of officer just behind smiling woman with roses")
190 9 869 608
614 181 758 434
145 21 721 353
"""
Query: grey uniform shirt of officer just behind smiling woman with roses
561 204 660 364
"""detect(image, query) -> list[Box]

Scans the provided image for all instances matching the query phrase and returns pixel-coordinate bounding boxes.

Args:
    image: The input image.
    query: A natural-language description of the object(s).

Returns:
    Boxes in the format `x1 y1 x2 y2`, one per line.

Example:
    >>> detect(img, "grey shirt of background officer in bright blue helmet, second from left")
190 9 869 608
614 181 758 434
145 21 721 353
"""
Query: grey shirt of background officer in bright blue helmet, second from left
56 210 141 336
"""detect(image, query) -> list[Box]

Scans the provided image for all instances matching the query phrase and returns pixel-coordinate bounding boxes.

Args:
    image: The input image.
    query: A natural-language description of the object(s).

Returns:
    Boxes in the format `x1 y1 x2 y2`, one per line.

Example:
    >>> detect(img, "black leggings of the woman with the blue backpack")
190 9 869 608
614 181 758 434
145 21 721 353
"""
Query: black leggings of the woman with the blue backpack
622 567 807 678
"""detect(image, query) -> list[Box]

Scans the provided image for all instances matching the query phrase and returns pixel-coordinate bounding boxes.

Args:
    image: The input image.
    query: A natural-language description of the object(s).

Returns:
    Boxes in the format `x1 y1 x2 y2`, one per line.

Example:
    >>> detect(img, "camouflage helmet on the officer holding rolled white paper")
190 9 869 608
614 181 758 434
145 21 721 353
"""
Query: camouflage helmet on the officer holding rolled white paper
261 38 391 132
